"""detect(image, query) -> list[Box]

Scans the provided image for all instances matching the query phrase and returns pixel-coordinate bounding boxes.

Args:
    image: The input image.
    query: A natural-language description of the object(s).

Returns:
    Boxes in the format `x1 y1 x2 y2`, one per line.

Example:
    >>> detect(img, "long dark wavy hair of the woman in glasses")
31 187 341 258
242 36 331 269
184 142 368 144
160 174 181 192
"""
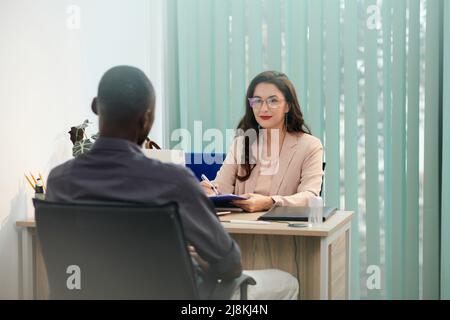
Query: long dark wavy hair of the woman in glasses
237 71 311 182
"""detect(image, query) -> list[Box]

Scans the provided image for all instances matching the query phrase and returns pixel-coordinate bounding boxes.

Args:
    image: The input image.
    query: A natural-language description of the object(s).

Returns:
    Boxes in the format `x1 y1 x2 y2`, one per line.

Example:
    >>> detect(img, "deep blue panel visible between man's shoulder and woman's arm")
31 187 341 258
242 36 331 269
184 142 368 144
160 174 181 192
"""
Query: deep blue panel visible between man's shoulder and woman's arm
186 153 226 181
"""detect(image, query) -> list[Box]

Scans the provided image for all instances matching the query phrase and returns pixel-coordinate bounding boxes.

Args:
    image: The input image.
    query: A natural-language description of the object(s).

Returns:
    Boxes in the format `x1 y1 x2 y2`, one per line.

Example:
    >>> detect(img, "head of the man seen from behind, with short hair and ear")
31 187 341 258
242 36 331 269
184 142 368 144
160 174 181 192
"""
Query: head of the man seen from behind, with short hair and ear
92 66 155 145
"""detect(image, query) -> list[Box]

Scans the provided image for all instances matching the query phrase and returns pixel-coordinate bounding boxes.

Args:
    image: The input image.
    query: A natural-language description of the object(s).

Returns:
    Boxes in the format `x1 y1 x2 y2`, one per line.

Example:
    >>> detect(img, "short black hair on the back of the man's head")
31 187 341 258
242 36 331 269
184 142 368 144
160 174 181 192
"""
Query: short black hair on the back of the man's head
97 66 155 126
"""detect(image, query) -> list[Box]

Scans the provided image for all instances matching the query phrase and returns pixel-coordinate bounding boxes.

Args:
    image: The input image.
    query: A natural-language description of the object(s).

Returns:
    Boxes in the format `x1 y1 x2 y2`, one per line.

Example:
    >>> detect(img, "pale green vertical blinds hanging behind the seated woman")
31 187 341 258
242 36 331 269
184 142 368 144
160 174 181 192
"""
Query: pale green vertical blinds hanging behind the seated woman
166 0 450 299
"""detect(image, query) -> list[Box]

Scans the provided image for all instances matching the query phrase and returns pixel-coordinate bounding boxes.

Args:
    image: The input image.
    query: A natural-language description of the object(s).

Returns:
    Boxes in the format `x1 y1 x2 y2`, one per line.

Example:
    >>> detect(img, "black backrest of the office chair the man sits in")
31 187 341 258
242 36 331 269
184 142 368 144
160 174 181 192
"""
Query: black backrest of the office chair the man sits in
34 200 198 299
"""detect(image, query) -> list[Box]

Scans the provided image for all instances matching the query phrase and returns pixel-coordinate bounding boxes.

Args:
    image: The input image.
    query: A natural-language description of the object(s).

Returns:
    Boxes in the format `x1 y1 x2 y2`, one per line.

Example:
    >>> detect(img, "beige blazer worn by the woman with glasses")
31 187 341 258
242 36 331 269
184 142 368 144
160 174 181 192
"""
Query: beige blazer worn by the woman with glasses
214 133 323 206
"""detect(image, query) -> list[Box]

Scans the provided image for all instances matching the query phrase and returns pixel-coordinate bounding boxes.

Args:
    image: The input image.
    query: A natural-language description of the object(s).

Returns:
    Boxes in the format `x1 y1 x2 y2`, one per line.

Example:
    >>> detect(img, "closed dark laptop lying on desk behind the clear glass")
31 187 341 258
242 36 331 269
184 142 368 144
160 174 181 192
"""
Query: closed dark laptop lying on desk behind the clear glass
258 207 336 222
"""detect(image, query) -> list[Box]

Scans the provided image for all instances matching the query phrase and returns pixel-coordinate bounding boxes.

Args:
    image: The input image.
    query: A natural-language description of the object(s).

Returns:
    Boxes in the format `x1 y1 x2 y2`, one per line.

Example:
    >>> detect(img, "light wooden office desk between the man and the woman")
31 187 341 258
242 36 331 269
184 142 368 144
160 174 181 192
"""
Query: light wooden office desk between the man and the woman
16 211 353 299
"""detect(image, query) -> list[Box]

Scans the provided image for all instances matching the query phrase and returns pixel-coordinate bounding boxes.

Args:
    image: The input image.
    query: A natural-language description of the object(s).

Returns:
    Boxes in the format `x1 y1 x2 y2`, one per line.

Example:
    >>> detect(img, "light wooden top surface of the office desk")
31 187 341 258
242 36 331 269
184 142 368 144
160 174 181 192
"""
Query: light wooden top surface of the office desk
16 211 353 237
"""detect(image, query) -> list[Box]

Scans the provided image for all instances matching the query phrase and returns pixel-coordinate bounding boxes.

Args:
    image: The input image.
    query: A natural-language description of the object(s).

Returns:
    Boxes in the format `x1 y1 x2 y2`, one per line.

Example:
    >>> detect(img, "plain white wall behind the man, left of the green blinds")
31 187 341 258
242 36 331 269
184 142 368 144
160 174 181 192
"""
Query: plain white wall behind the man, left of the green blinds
0 0 164 299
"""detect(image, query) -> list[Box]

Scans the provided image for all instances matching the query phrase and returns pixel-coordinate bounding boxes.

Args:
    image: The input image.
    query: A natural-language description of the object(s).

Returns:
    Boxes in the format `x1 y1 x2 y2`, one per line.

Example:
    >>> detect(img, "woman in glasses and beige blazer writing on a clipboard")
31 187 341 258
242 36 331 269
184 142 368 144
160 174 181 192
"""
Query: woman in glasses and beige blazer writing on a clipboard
201 71 323 212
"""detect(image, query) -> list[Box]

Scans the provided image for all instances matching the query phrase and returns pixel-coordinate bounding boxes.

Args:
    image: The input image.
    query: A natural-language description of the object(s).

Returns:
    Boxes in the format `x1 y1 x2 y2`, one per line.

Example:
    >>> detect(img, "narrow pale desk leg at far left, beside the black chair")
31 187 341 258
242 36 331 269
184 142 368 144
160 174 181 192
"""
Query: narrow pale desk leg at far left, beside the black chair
22 228 34 300
